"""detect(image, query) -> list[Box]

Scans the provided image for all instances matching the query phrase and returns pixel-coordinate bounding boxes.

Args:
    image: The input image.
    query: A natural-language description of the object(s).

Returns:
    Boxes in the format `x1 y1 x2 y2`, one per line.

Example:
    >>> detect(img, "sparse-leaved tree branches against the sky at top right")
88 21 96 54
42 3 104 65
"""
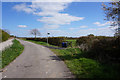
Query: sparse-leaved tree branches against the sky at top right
102 0 120 36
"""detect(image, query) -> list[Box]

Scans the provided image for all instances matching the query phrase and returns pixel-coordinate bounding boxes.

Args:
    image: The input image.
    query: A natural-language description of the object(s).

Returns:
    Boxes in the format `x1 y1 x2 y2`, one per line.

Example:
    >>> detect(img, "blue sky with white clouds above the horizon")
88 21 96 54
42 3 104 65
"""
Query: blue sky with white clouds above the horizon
2 2 114 37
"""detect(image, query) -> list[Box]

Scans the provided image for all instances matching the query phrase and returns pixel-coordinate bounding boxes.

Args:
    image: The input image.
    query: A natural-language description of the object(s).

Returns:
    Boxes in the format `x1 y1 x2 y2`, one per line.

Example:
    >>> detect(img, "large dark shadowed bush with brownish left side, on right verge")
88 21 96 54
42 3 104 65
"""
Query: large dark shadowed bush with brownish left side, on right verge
76 36 120 63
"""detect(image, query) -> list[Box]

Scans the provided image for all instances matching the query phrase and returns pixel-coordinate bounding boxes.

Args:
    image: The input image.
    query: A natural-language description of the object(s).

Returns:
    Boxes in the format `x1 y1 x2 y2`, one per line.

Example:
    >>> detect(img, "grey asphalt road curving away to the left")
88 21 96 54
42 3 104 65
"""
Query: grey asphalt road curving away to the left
2 40 74 78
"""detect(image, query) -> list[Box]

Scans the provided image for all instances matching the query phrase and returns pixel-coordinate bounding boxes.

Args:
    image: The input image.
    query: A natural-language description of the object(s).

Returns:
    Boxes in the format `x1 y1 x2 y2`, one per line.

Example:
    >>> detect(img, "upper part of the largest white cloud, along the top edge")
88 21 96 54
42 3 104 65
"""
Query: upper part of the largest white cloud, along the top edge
30 2 69 14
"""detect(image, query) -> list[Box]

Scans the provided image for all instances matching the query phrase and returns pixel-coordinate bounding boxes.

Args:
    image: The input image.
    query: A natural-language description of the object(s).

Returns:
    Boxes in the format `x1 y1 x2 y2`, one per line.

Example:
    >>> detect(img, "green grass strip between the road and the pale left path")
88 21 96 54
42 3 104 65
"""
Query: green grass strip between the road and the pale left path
1 39 24 68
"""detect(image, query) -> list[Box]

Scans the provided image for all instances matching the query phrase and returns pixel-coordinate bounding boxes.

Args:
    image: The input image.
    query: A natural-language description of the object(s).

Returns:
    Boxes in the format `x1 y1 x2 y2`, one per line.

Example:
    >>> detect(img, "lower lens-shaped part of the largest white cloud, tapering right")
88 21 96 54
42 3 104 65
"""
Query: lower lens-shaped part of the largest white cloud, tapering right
37 14 84 25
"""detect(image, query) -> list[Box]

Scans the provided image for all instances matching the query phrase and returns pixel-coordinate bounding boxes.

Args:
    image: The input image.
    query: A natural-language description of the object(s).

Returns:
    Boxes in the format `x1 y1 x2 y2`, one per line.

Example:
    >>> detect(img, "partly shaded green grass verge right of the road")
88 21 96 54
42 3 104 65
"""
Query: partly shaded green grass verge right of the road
51 48 120 78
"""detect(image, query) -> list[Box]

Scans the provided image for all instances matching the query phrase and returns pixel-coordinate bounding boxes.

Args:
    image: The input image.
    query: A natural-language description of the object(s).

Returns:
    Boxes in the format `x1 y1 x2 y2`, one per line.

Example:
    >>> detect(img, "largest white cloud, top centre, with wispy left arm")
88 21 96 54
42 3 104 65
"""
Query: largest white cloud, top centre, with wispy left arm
13 0 84 28
